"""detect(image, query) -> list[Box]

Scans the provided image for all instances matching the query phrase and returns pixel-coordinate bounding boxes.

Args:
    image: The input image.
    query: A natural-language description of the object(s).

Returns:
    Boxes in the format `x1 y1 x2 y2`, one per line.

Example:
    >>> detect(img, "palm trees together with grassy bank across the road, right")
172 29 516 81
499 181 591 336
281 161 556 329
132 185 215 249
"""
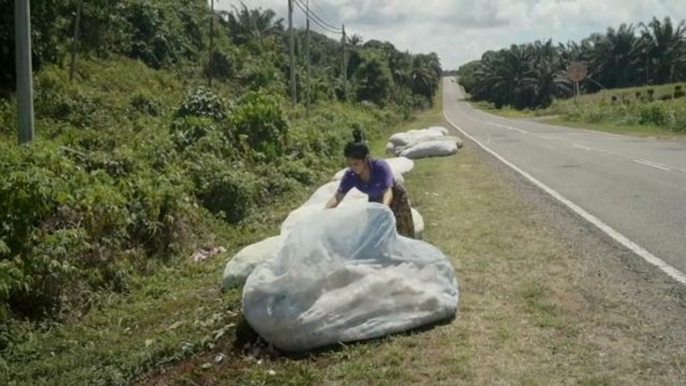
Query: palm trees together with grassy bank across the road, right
458 18 686 134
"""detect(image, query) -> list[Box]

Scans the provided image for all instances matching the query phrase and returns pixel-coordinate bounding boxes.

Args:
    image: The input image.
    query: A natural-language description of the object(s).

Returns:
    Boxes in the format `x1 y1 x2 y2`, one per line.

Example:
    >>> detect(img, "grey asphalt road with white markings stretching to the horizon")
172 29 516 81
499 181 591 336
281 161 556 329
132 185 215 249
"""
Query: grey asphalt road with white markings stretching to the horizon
443 78 686 276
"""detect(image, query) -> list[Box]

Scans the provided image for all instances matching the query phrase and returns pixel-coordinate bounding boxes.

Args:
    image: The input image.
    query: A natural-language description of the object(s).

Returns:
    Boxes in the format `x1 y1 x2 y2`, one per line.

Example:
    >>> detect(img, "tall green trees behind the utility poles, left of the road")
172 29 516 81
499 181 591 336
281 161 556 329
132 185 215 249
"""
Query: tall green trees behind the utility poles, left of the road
0 0 441 108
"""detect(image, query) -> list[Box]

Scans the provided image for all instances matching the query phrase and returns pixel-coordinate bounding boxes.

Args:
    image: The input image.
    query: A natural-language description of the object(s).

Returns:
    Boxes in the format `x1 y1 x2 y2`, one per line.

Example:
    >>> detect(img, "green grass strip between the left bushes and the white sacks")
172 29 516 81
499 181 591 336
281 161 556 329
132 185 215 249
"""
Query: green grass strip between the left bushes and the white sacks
0 185 308 385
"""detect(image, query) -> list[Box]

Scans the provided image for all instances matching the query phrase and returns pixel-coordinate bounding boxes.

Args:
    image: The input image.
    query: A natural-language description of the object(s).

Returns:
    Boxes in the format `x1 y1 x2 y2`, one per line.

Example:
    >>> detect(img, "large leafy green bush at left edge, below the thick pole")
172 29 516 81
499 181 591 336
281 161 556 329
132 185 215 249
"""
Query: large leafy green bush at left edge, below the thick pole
0 142 191 324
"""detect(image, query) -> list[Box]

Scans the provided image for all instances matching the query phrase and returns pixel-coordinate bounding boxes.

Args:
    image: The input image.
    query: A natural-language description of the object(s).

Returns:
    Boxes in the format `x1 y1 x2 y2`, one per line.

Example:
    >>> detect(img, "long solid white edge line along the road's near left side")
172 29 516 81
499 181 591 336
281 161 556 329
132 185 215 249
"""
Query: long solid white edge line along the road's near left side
443 110 686 285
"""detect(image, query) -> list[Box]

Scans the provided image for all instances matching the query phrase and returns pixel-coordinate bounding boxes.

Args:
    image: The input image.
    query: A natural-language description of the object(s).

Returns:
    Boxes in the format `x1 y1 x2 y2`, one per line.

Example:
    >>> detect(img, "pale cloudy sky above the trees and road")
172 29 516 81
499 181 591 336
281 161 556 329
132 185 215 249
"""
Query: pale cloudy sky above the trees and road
215 0 686 69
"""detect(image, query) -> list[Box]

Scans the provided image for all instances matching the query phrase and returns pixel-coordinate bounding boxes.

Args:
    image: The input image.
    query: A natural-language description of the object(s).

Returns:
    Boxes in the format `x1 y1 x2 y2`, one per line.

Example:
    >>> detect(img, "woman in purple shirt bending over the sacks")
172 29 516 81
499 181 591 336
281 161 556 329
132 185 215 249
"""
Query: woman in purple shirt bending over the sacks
326 130 414 238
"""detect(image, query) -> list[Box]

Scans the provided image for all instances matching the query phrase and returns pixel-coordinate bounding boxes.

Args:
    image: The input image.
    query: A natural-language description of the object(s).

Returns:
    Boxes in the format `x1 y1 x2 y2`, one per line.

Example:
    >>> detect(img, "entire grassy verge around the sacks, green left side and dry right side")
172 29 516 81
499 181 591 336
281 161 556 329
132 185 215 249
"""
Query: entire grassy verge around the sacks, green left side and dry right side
9 80 686 386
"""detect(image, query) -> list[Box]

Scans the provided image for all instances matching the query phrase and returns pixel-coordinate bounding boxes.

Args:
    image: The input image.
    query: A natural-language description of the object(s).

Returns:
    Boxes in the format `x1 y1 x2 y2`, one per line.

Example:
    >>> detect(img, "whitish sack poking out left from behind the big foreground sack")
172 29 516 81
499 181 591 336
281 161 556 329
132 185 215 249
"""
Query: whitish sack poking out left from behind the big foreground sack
222 236 284 290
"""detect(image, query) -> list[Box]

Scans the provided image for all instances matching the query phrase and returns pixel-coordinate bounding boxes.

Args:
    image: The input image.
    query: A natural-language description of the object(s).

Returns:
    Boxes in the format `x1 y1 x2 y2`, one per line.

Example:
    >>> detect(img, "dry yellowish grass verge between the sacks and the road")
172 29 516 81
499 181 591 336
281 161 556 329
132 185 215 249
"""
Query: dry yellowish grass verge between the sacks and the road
134 81 686 386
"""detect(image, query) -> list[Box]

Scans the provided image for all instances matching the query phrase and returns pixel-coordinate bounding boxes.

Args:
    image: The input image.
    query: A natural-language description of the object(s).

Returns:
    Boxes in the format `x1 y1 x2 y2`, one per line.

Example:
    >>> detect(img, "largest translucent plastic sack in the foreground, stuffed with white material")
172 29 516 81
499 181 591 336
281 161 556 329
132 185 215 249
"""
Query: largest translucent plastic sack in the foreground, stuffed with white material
243 203 458 351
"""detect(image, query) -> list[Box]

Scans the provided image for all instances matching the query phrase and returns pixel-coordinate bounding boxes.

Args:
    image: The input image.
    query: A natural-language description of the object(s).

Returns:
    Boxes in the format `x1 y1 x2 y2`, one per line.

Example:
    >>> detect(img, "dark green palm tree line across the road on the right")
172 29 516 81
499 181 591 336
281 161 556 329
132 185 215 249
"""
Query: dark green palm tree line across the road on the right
458 17 686 109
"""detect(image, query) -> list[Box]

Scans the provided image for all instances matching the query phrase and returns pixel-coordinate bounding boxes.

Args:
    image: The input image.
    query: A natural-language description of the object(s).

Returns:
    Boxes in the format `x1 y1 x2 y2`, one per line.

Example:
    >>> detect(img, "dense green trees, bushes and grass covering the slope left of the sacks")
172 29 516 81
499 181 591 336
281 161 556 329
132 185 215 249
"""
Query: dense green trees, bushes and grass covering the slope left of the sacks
0 0 441 385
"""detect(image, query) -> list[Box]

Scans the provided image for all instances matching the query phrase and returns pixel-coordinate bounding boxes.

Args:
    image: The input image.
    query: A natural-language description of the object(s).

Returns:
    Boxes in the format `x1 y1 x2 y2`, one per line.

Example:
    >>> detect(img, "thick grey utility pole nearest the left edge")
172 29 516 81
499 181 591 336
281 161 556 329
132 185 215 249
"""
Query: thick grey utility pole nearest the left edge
14 0 35 144
